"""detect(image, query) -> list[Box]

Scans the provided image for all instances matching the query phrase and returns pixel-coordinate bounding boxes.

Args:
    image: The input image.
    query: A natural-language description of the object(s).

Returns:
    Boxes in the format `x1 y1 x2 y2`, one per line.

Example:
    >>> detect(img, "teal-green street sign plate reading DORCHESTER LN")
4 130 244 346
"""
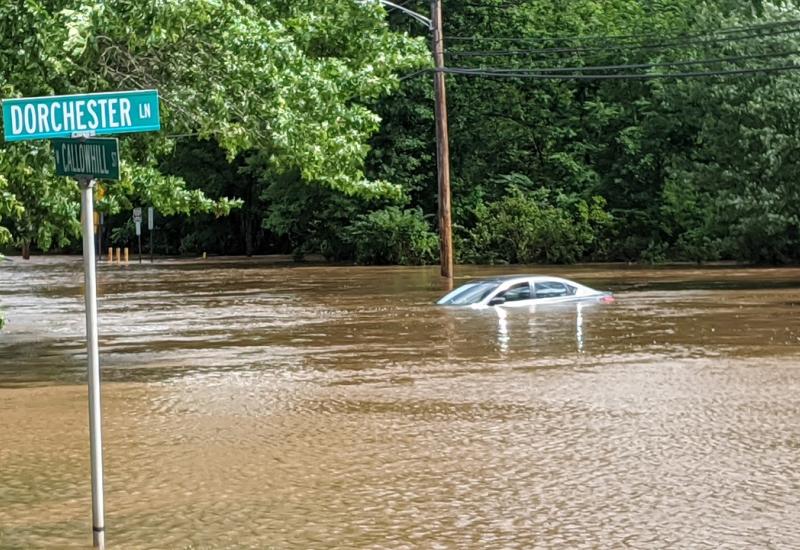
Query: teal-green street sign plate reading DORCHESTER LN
3 90 161 141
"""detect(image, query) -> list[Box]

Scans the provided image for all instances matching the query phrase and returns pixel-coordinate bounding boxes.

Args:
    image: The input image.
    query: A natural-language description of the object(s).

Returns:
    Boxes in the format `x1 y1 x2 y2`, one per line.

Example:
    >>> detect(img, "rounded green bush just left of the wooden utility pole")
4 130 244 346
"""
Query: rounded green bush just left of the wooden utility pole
345 206 439 265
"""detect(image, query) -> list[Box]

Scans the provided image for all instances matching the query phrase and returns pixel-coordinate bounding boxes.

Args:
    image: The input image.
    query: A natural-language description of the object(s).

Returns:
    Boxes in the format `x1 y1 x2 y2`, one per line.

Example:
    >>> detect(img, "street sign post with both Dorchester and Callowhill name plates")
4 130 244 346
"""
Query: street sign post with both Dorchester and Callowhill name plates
2 90 166 549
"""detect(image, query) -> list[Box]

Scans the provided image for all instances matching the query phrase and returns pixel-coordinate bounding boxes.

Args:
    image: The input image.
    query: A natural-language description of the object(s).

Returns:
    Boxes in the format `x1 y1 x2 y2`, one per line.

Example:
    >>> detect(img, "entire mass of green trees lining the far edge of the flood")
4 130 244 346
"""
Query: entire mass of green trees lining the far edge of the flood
0 0 800 263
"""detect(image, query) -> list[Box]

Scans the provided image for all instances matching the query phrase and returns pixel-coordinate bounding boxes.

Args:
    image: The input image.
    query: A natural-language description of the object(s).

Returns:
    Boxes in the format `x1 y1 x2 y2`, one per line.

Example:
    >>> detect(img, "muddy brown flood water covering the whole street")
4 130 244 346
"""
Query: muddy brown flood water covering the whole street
0 258 800 549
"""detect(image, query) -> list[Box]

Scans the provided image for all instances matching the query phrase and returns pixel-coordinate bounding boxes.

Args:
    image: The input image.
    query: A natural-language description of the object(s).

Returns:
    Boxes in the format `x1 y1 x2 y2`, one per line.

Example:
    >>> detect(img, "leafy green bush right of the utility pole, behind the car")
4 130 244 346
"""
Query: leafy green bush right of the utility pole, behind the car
461 186 611 263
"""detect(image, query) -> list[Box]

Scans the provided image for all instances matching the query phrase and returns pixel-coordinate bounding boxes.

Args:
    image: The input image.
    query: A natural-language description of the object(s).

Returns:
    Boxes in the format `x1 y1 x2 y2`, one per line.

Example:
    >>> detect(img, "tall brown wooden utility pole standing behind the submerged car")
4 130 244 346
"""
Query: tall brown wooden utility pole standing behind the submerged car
431 0 453 280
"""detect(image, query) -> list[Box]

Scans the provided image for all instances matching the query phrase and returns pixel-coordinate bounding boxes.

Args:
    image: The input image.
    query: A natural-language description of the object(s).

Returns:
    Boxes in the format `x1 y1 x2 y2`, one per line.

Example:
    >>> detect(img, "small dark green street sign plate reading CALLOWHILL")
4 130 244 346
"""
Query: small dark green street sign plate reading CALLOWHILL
52 138 119 180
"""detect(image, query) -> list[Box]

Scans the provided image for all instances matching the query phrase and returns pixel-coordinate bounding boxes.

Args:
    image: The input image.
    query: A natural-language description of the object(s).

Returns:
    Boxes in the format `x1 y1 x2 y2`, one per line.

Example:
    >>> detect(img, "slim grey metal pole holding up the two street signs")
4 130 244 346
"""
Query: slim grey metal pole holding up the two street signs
80 179 106 550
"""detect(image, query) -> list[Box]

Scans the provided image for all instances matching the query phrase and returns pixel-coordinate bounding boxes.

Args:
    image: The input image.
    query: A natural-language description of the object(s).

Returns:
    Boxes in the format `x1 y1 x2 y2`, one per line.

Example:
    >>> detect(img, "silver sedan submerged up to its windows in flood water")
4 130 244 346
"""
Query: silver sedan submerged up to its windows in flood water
436 275 614 308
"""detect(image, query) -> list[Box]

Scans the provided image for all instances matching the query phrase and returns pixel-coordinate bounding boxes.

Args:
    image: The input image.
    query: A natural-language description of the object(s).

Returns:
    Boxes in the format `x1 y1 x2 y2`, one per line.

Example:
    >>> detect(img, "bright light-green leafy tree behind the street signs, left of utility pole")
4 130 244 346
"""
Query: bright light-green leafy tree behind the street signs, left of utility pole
0 0 426 254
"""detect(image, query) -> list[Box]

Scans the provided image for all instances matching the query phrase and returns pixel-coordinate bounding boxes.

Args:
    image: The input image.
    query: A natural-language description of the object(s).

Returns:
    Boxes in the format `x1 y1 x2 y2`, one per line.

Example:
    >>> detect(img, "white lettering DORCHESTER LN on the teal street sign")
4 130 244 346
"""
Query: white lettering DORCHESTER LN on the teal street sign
10 97 145 135
